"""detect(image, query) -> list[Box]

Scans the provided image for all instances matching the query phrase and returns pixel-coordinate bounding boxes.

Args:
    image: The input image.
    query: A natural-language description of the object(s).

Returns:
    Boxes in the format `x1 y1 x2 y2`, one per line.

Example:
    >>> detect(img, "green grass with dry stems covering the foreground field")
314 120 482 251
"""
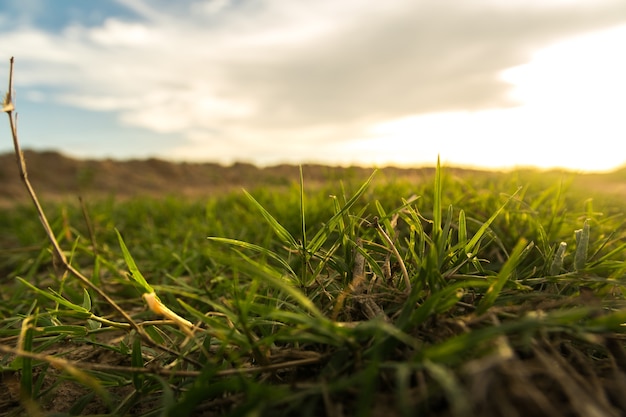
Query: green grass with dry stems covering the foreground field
0 164 626 416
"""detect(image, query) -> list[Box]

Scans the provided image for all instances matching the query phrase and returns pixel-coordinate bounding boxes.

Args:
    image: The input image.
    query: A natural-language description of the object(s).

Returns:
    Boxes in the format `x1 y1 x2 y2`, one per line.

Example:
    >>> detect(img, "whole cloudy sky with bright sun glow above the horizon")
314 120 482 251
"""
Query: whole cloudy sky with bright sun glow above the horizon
0 0 626 171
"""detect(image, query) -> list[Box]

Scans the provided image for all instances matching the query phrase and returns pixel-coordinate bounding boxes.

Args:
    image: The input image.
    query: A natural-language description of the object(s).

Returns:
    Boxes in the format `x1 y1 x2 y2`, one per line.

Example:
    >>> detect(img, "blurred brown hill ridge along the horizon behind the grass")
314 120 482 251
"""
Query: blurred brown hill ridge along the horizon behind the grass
0 151 626 206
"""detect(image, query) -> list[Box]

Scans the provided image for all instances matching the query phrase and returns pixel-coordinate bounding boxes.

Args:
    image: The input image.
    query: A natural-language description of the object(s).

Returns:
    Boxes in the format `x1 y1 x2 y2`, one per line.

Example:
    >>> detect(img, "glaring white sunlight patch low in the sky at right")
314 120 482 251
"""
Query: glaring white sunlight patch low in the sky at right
360 26 626 171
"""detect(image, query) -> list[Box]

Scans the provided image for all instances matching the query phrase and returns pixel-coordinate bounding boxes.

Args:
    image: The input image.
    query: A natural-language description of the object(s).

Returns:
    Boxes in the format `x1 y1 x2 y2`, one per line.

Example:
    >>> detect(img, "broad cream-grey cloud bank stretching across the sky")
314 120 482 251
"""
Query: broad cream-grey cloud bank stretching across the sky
0 0 626 162
